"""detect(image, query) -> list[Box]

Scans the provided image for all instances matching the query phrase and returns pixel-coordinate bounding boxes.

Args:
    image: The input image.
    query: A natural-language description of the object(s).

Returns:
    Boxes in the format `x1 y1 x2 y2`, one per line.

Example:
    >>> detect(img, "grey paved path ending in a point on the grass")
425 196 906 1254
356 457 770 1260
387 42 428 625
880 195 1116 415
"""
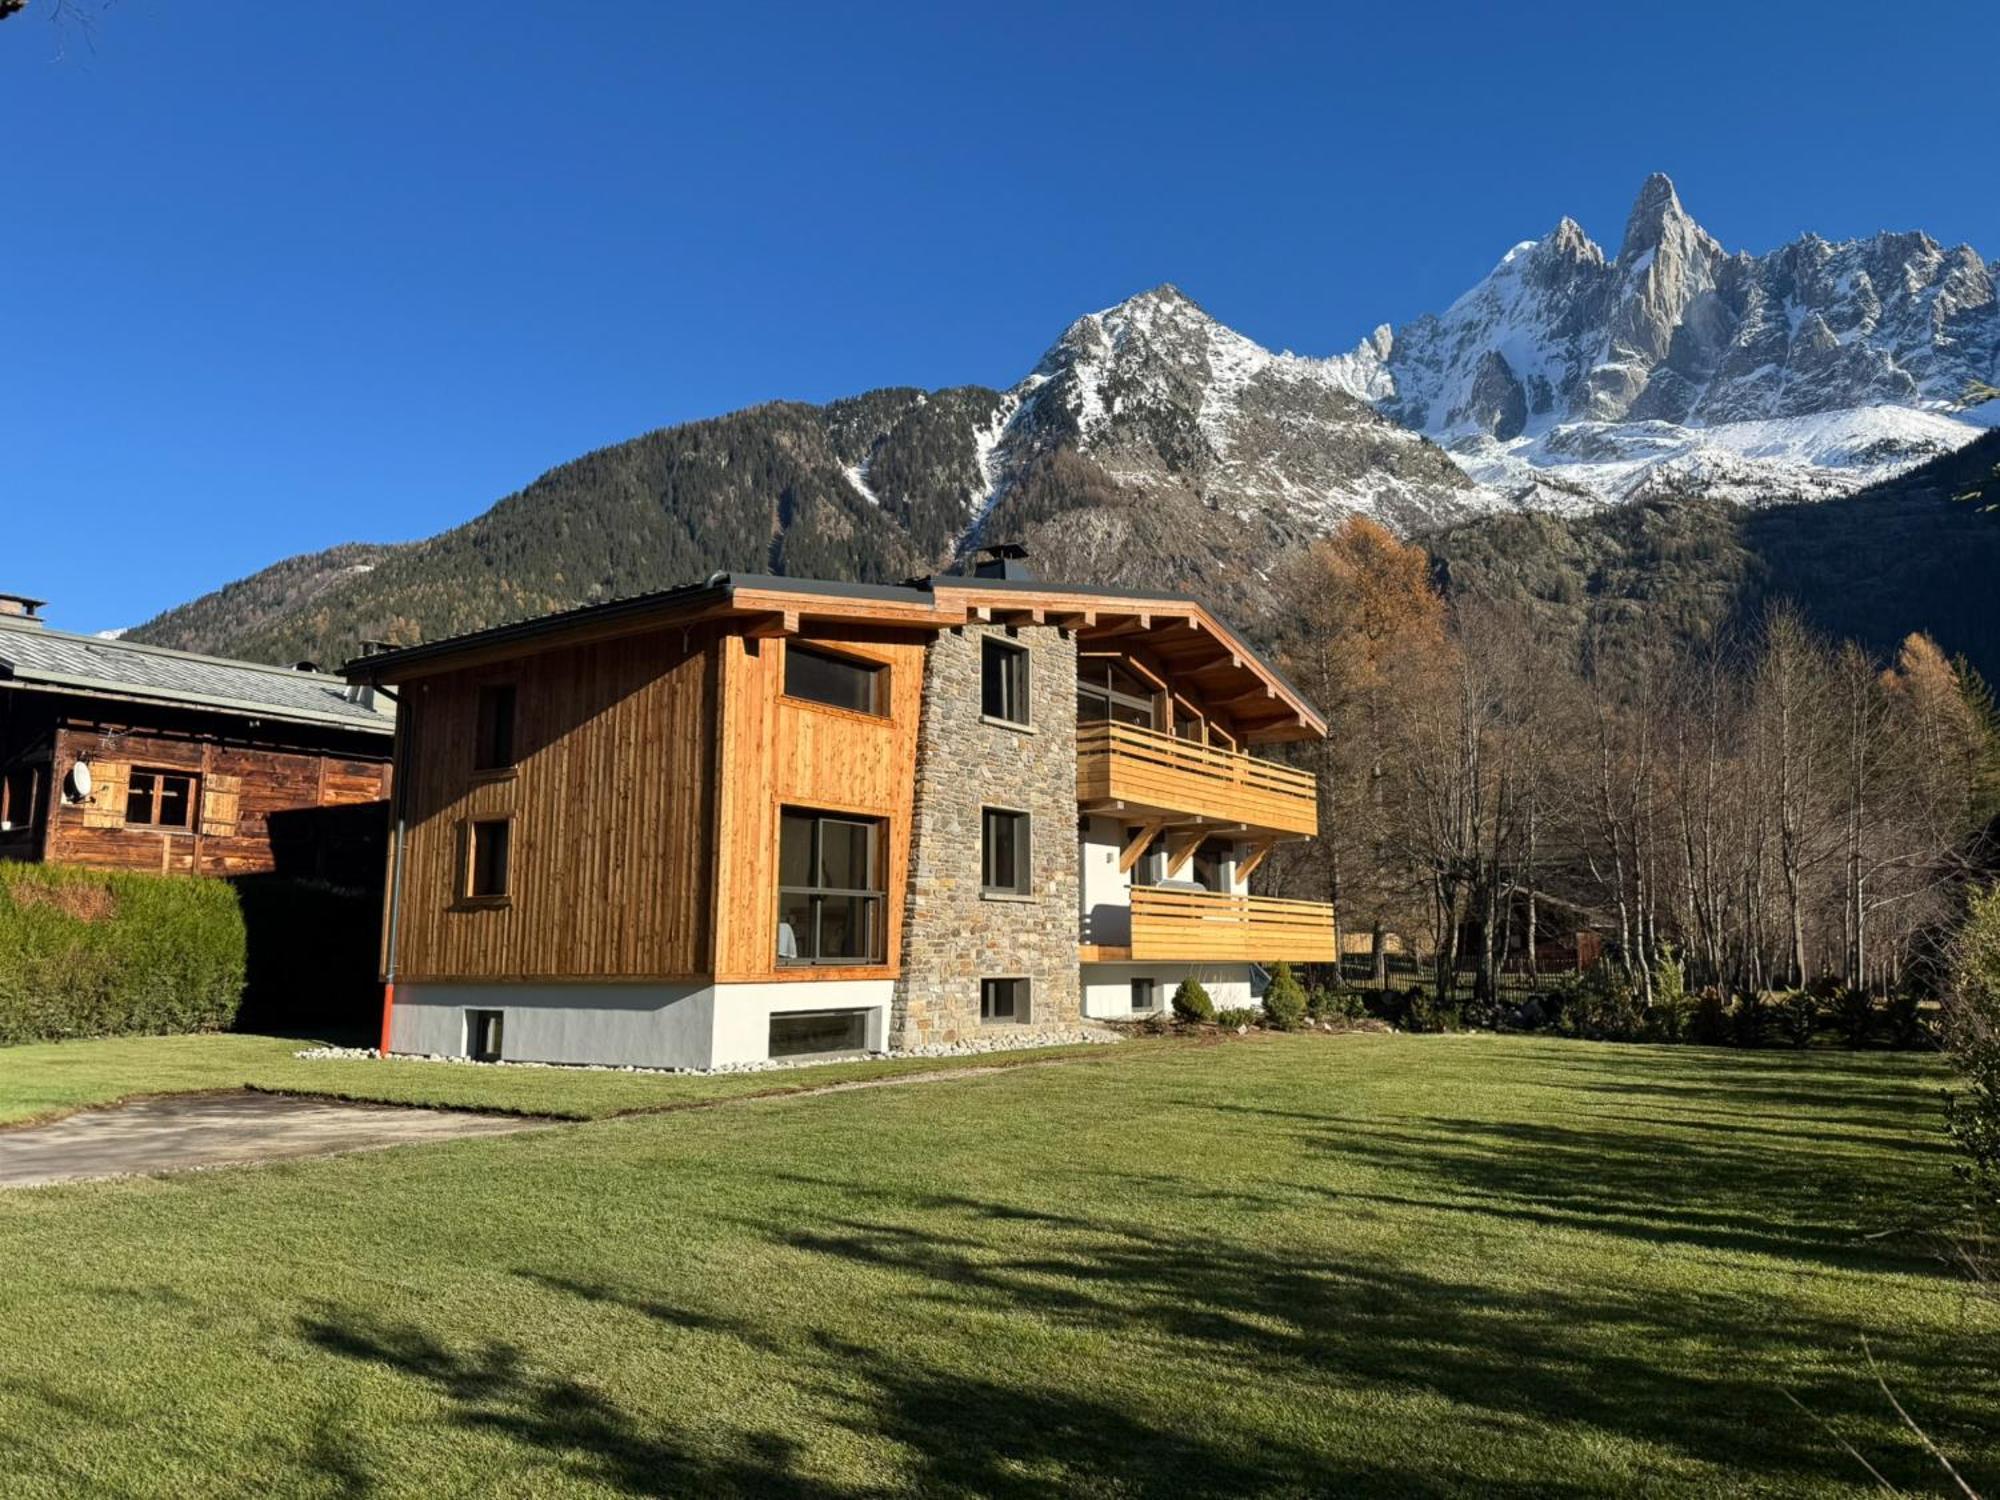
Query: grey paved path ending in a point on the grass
0 1094 546 1188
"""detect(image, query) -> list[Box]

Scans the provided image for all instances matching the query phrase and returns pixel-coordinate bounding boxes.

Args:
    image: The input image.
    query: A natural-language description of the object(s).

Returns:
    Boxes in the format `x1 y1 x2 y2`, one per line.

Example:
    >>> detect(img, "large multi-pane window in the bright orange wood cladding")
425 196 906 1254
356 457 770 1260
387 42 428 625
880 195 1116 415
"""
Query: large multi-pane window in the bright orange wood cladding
778 808 886 964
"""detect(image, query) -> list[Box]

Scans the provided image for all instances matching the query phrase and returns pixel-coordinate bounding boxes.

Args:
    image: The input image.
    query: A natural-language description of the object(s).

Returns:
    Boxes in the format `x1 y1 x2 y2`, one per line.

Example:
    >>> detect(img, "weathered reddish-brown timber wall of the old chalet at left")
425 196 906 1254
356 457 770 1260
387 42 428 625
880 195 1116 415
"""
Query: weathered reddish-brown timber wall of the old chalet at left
42 724 390 876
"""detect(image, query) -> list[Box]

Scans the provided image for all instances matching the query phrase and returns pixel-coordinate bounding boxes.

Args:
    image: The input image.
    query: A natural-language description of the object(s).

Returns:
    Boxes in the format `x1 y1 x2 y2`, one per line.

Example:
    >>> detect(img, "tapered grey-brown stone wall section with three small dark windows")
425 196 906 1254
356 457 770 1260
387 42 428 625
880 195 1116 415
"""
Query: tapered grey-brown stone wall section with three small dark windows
890 626 1082 1046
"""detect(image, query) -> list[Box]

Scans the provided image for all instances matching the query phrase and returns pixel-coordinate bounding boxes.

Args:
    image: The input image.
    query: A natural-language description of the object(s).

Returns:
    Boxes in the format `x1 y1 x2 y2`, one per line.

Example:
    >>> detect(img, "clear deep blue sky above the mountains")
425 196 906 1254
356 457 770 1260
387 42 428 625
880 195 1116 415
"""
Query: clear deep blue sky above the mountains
0 0 2000 630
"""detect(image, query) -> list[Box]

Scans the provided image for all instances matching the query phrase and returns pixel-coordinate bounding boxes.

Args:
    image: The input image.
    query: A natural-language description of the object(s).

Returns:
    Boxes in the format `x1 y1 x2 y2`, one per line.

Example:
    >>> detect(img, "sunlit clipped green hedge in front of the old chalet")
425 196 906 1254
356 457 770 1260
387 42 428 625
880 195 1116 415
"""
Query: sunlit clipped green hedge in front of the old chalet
0 862 246 1044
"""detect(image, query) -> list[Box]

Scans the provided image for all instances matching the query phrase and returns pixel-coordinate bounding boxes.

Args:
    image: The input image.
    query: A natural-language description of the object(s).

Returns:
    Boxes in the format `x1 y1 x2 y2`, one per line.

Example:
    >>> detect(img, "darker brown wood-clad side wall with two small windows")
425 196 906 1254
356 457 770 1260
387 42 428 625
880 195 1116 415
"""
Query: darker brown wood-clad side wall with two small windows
396 628 718 980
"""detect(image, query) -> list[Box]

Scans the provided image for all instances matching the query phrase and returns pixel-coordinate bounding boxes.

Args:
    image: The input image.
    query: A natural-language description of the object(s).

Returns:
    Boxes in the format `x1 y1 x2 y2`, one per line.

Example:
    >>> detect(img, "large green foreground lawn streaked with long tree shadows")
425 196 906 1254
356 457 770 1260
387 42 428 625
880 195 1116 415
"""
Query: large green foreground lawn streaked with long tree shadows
0 1036 2000 1500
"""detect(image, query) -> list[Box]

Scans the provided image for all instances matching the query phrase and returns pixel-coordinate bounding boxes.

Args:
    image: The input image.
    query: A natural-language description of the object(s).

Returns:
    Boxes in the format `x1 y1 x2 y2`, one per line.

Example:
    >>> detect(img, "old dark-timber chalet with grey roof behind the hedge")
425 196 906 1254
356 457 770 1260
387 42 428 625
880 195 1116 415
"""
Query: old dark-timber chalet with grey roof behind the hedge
0 594 396 882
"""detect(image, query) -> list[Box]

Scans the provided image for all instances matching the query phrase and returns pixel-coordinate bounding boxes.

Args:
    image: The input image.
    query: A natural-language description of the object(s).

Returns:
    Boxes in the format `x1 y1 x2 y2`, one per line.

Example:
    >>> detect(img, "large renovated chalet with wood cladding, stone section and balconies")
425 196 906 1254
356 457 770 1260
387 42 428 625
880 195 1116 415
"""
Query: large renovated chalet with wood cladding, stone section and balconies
346 556 1334 1068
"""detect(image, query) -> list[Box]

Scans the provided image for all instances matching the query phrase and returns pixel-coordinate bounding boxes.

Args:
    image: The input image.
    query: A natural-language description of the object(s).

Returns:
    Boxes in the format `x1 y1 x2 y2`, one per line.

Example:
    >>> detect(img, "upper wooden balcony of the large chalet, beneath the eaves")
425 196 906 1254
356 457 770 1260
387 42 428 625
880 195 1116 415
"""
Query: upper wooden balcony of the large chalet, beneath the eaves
1076 722 1320 838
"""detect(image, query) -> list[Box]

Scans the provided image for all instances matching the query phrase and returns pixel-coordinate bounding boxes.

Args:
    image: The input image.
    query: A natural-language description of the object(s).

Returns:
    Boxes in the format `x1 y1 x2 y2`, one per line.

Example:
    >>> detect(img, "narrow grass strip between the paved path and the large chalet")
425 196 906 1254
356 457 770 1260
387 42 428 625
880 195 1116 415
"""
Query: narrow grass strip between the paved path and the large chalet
0 1034 1158 1126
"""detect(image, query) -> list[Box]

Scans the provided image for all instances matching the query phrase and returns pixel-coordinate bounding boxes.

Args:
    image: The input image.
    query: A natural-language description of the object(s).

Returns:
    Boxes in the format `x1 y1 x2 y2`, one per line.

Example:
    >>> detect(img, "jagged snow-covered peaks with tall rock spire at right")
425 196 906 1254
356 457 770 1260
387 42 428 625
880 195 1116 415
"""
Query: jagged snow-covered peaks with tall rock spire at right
1328 174 2000 508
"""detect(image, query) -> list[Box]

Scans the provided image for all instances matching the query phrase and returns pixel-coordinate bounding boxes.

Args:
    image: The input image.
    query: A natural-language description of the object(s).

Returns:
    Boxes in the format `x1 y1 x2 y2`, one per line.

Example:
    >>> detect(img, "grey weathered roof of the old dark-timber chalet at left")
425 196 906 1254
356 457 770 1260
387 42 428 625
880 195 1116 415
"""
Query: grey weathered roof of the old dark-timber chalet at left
0 616 396 734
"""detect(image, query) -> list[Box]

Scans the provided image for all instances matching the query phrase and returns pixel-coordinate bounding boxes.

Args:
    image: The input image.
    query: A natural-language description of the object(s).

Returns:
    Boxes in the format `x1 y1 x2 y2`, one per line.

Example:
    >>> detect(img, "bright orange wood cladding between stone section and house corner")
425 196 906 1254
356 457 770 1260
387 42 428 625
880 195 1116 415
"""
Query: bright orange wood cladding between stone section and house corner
714 626 928 980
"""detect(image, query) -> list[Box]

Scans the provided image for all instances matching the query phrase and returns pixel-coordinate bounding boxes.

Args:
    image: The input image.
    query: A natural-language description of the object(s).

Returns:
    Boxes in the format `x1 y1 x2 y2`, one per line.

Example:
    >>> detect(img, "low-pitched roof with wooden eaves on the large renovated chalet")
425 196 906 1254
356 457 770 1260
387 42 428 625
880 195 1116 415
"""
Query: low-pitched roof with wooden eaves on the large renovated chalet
342 574 1326 738
